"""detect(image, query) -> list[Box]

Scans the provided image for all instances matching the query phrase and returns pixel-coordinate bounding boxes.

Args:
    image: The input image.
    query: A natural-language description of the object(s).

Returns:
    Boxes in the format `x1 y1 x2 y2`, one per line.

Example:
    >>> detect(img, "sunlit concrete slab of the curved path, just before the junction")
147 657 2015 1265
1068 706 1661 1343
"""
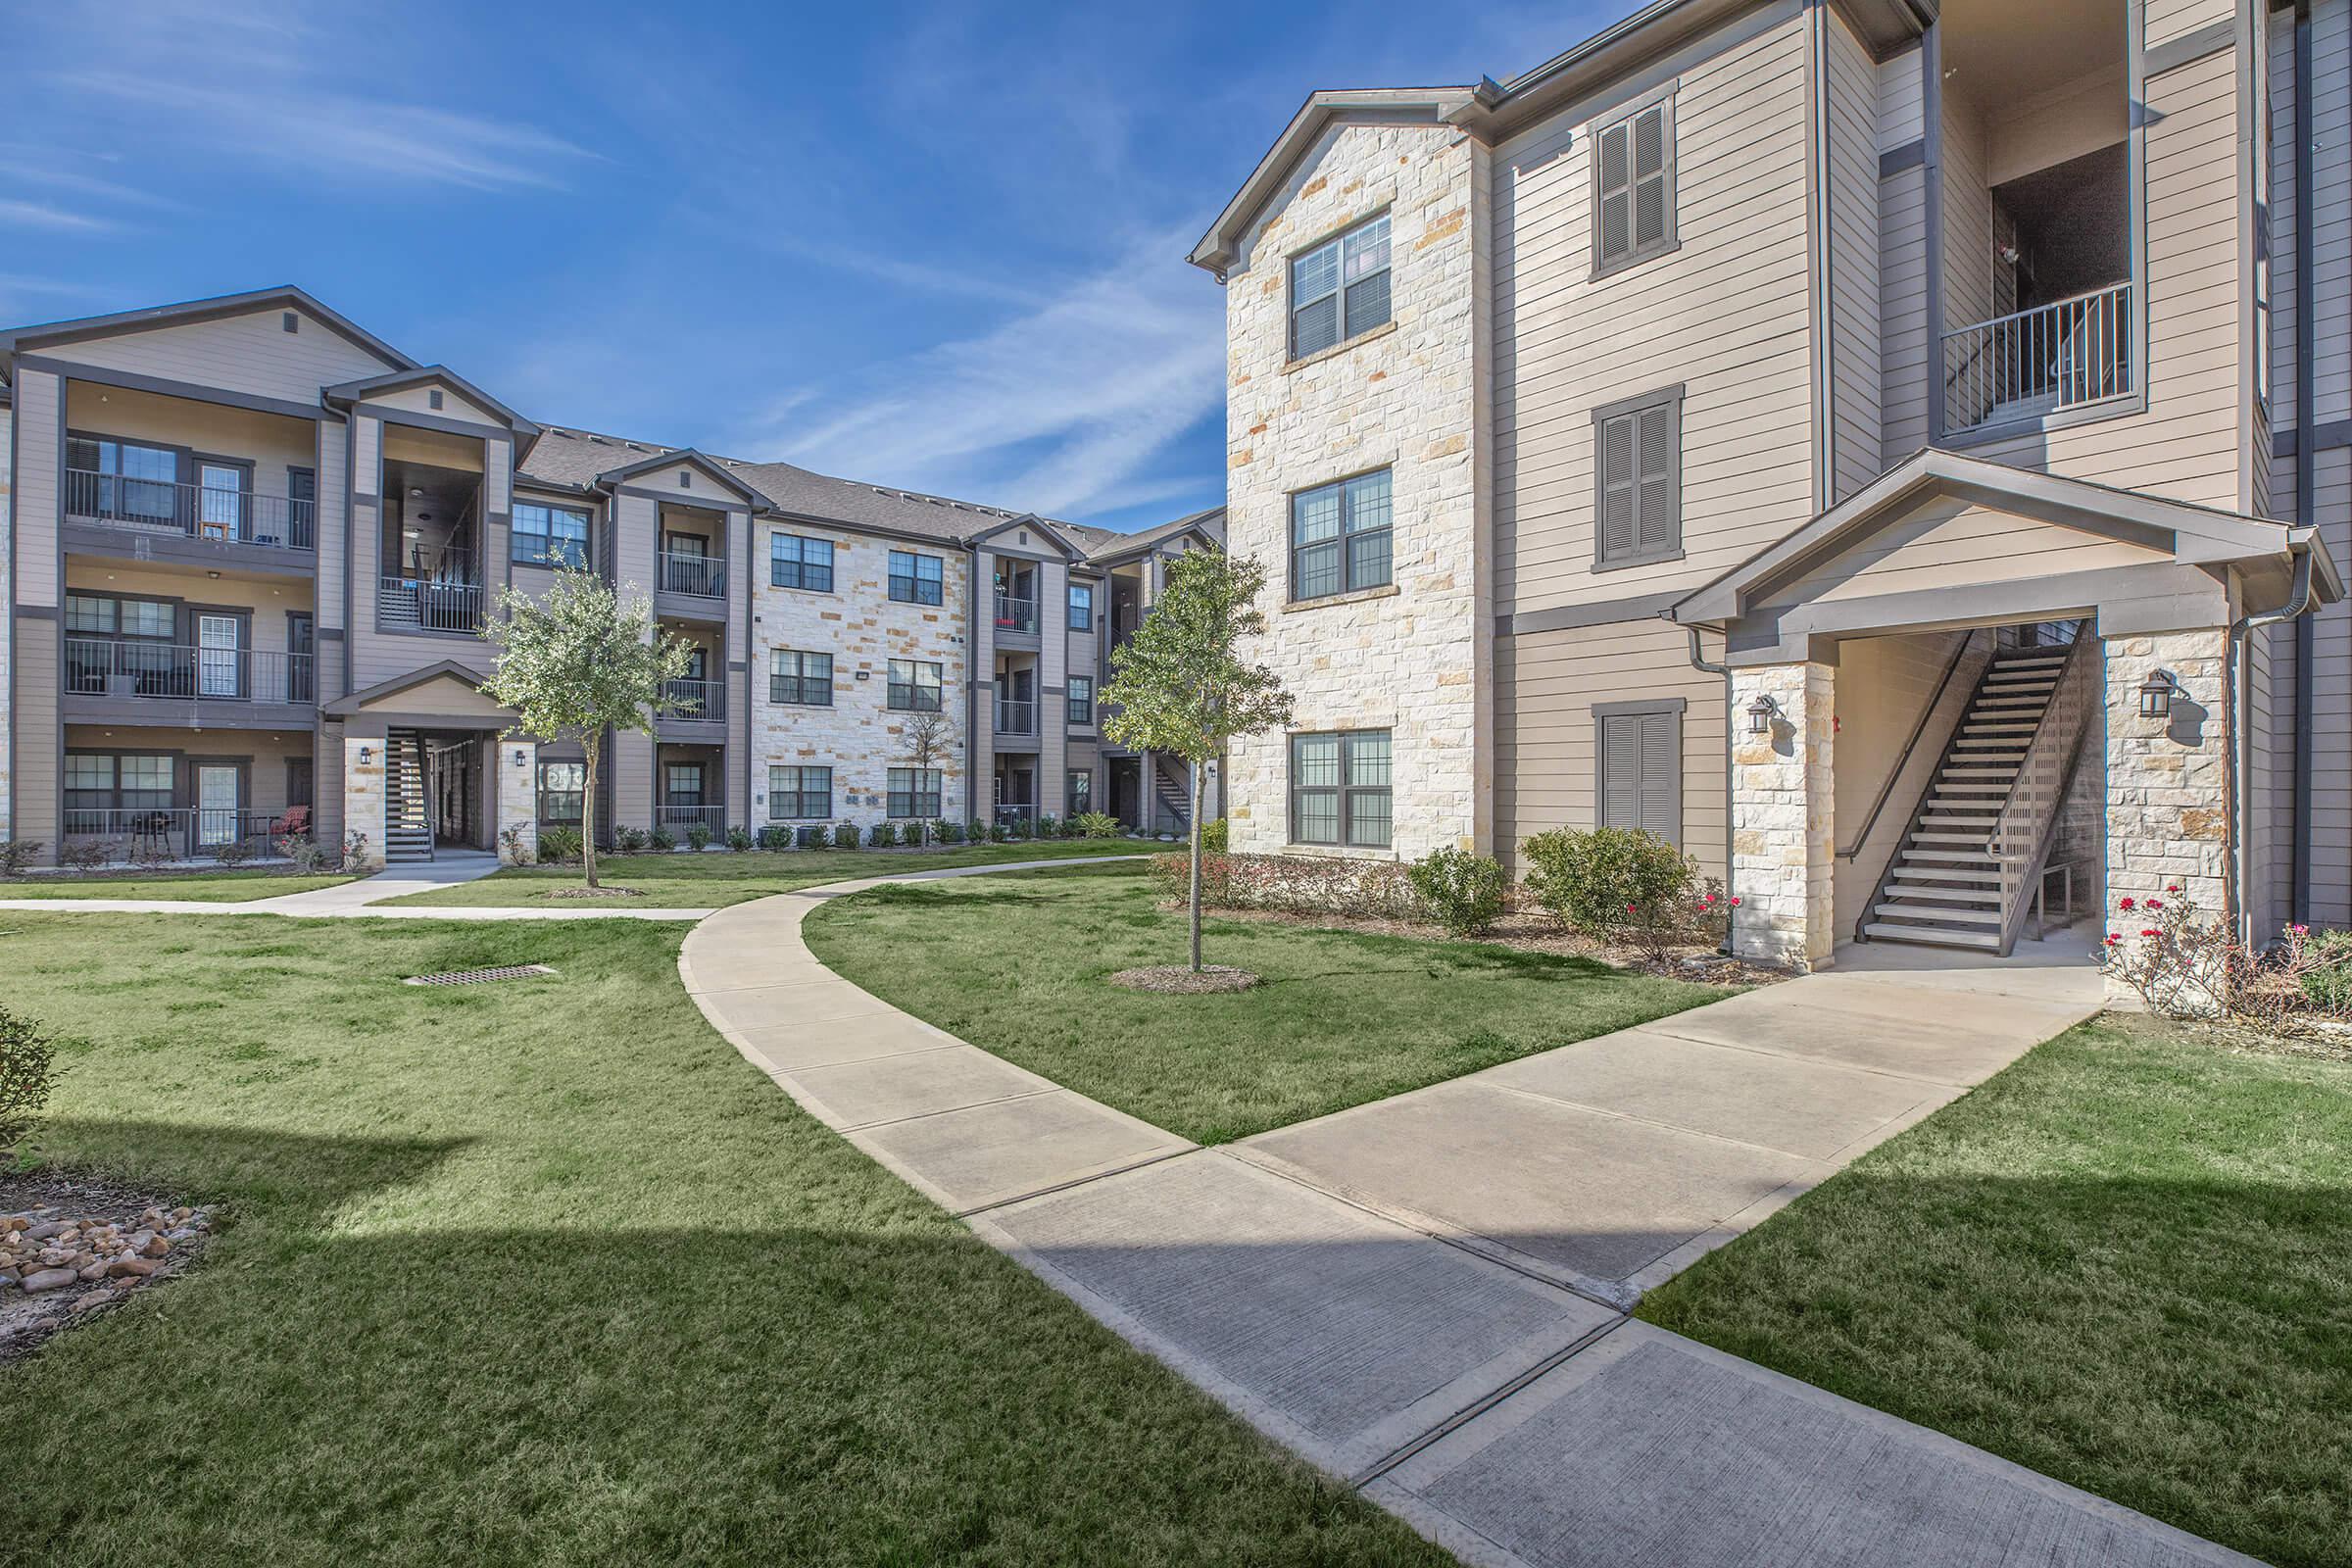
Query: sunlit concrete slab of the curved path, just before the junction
847 1089 1193 1213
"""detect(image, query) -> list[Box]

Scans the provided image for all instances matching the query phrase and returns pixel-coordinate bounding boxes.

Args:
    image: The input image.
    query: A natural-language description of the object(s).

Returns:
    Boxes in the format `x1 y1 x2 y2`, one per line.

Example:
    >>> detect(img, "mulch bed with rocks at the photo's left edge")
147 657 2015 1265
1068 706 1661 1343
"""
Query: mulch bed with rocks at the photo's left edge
0 1171 214 1366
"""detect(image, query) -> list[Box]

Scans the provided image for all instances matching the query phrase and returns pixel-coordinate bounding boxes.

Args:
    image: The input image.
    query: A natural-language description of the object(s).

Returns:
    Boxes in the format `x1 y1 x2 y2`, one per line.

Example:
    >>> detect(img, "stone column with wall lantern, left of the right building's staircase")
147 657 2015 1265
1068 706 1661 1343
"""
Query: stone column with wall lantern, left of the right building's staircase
1731 662 1837 971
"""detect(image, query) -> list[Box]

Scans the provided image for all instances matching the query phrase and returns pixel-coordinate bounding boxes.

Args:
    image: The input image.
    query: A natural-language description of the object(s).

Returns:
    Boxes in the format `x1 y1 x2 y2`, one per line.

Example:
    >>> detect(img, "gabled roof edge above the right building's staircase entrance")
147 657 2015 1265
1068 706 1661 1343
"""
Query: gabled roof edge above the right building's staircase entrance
1668 447 2342 625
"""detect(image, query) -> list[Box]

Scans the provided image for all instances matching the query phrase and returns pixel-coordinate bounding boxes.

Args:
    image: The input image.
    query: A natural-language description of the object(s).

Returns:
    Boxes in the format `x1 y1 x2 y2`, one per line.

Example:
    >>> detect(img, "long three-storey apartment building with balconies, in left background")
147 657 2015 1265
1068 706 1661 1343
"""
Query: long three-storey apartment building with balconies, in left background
0 289 1221 879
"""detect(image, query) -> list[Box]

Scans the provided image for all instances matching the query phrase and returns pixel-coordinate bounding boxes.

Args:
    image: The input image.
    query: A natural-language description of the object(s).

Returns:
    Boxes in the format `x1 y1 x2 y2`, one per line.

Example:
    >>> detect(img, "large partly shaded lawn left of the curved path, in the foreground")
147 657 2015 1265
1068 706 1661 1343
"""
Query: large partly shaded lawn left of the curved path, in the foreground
0 914 1451 1568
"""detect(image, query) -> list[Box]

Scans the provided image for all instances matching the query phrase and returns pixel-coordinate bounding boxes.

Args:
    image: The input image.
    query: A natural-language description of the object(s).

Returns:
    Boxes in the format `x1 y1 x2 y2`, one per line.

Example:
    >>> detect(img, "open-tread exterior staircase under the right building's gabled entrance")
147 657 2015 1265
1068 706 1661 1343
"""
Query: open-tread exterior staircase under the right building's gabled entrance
1856 632 2098 955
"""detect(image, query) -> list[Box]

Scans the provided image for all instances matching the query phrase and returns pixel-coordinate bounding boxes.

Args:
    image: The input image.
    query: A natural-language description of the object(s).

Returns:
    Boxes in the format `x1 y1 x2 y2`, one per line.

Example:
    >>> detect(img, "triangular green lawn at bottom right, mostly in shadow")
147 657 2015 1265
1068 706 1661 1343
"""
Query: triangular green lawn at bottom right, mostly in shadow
1640 1015 2352 1568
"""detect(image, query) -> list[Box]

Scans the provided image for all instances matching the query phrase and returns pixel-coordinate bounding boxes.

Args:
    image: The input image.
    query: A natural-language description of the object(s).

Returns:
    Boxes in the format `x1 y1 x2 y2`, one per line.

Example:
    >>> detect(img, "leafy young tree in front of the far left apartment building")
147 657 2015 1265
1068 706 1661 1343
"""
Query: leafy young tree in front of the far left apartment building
482 566 694 886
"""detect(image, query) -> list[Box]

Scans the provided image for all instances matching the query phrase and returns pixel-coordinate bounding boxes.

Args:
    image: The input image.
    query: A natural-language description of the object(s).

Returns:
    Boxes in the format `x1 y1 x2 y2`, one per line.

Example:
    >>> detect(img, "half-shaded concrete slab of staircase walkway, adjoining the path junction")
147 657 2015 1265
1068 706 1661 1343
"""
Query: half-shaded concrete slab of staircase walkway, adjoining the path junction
1233 1077 1828 1304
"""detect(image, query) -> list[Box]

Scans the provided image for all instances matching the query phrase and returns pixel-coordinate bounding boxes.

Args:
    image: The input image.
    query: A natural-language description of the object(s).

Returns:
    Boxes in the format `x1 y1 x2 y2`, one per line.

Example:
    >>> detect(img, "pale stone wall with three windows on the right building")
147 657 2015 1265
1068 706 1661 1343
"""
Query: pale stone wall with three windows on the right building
1225 124 1494 858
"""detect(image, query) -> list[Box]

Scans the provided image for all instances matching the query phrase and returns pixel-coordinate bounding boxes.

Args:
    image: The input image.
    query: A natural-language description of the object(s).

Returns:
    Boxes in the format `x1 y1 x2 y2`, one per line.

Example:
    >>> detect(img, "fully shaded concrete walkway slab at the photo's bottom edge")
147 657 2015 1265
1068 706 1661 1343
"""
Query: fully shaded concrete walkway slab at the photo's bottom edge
1366 1324 2253 1568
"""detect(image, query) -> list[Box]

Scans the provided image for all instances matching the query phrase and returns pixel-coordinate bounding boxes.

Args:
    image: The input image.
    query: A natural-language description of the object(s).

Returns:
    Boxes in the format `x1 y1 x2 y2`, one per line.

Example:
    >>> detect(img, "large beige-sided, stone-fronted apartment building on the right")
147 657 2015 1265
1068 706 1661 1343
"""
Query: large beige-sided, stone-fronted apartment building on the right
1190 0 2352 966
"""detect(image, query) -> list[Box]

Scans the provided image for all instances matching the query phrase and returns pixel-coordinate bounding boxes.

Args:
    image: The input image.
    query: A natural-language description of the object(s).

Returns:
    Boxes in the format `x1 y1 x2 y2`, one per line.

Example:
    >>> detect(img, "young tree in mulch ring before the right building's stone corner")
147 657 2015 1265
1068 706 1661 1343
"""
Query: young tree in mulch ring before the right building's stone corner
1103 550 1292 971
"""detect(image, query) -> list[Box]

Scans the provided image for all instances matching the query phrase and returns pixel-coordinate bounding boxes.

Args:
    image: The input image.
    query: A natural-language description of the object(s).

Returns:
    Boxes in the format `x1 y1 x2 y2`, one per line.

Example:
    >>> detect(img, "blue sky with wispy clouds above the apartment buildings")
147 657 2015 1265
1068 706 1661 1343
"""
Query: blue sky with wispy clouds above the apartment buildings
0 0 1630 526
